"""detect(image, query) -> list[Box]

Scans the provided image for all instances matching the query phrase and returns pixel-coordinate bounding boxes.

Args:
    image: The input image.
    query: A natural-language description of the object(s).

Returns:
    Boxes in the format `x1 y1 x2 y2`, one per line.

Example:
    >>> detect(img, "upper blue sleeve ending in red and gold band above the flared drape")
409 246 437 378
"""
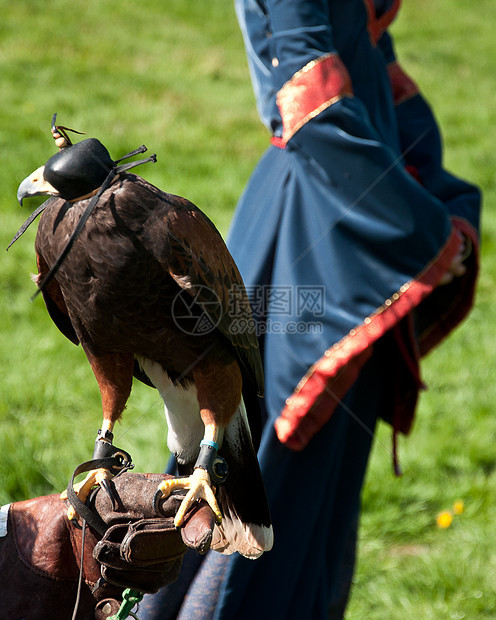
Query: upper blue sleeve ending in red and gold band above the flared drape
236 0 352 144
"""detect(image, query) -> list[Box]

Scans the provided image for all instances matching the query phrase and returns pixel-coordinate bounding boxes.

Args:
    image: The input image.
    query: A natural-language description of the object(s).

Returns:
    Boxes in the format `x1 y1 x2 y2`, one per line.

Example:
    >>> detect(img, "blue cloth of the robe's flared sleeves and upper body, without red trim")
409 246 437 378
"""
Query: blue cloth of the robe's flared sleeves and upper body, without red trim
229 0 480 432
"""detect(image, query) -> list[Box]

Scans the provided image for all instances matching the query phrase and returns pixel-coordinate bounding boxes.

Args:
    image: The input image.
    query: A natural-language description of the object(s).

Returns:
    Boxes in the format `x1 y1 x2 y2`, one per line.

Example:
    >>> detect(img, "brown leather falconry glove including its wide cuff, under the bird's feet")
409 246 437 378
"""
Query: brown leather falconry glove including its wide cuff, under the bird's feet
0 472 214 620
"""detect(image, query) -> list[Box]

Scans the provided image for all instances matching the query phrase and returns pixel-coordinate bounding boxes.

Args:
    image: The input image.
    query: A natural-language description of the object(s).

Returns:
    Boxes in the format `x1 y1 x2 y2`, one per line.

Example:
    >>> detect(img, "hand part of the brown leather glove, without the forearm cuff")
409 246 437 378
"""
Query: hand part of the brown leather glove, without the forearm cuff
93 473 213 593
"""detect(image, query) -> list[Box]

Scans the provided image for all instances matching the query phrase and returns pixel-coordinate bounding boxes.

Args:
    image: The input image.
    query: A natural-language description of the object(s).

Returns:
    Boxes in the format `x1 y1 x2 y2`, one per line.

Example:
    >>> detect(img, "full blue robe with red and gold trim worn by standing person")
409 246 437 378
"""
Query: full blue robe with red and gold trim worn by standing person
140 0 480 620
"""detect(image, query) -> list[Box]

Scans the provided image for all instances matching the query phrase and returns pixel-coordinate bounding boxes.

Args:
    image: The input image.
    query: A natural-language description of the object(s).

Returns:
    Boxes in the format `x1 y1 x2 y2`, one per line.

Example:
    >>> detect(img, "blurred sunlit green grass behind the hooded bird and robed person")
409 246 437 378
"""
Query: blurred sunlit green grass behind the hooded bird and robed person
0 0 496 620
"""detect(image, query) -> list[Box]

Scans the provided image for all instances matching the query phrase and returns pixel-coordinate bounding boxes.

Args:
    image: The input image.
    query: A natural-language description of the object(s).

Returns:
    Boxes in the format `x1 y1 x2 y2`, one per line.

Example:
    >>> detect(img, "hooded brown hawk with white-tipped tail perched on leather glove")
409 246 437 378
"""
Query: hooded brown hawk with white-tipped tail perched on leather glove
18 117 273 558
